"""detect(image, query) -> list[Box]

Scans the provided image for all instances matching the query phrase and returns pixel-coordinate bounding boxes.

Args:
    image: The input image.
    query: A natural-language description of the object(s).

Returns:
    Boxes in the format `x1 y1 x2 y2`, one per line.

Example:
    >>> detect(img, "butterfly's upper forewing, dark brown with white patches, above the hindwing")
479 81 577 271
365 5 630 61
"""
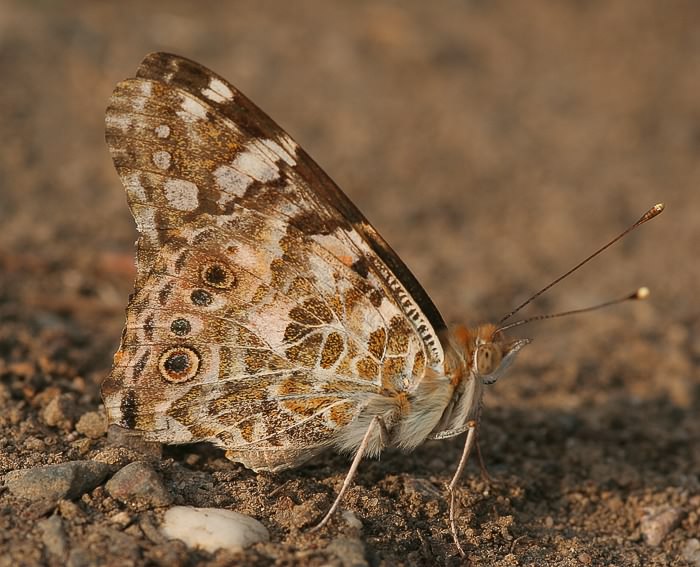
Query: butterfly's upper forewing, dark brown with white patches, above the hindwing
107 53 445 364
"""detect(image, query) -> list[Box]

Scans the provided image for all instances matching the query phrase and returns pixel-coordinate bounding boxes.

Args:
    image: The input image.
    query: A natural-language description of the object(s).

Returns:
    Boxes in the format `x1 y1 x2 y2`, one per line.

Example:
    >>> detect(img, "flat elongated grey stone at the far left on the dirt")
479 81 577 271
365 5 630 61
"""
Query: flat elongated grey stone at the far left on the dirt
5 461 111 501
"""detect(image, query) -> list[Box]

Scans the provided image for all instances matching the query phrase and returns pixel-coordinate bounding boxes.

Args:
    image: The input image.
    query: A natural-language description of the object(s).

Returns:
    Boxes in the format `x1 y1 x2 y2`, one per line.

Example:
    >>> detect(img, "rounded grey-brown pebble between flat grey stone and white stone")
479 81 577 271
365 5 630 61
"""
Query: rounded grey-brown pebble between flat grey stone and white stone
105 461 173 507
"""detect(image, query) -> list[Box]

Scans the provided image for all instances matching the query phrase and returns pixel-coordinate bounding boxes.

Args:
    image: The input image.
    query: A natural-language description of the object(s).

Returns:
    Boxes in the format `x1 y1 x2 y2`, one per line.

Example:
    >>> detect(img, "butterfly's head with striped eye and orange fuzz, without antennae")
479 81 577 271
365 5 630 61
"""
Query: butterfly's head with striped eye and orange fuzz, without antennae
452 323 530 384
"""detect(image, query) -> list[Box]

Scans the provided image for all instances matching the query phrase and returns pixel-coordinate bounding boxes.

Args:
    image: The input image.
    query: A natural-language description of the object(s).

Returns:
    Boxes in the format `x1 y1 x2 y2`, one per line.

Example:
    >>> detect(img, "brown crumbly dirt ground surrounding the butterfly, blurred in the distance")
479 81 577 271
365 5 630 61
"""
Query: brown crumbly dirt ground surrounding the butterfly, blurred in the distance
0 0 700 567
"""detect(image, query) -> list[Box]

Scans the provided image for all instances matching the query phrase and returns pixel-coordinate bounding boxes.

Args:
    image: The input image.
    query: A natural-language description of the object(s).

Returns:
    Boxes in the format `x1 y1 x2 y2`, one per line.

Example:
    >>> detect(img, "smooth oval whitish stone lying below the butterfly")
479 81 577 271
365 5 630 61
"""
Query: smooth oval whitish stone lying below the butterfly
160 506 270 553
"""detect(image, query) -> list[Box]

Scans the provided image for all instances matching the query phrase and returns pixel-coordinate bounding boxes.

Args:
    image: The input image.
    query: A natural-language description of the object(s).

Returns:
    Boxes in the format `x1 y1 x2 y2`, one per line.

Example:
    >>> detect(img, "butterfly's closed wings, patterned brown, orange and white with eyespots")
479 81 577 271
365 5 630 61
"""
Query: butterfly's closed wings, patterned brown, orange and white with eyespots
103 53 445 469
